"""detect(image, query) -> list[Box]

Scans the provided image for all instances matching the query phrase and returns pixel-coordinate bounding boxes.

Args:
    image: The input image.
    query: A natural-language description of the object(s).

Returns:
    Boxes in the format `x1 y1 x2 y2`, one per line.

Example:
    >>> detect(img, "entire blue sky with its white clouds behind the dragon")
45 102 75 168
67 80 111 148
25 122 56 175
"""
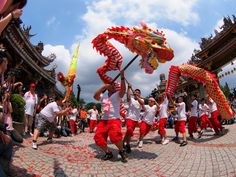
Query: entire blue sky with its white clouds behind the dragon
19 0 236 101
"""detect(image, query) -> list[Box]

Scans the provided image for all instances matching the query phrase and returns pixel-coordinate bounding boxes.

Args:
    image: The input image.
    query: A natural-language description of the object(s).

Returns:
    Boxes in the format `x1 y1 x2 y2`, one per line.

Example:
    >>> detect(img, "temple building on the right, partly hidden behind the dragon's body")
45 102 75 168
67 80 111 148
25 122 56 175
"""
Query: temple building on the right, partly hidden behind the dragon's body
152 15 236 97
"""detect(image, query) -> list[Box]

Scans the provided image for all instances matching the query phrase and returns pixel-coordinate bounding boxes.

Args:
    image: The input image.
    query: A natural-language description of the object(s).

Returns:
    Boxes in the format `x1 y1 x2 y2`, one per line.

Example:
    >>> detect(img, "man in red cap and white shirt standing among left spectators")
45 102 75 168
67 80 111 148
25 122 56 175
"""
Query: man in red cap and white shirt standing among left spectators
24 83 38 135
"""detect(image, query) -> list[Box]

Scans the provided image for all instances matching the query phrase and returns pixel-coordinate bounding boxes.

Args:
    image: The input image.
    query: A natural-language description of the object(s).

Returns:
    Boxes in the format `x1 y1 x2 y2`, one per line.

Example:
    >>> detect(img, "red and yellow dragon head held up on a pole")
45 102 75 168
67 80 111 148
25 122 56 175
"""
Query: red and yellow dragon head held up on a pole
126 23 174 74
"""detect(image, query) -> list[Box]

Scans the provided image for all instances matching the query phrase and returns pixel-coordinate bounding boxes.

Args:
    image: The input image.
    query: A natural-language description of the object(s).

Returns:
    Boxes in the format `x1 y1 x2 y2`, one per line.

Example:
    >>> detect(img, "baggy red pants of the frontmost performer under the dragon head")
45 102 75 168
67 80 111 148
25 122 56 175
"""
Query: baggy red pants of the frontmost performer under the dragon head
94 119 122 147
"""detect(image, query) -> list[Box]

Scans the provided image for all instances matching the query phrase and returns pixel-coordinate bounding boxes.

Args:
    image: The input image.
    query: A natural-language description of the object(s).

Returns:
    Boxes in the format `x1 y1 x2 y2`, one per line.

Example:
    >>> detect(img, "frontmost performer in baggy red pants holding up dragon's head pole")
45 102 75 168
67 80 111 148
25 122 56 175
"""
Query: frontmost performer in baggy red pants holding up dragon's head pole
94 71 128 162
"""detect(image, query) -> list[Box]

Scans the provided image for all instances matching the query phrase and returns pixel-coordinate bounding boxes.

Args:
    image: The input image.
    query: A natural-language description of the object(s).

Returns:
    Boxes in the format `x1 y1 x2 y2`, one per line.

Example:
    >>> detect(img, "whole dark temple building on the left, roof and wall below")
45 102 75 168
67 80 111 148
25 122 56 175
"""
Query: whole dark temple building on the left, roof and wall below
0 19 61 95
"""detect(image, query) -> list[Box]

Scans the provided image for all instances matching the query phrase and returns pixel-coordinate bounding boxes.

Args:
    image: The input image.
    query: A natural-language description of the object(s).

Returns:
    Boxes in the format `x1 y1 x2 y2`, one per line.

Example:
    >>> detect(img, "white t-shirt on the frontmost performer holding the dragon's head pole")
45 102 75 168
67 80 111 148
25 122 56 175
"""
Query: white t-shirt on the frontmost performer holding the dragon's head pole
101 91 121 120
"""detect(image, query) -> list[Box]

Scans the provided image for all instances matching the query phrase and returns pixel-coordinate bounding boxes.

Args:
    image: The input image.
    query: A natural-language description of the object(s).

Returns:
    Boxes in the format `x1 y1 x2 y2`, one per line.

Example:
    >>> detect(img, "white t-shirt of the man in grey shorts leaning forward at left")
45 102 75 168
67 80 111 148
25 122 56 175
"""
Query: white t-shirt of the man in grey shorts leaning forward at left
40 101 61 122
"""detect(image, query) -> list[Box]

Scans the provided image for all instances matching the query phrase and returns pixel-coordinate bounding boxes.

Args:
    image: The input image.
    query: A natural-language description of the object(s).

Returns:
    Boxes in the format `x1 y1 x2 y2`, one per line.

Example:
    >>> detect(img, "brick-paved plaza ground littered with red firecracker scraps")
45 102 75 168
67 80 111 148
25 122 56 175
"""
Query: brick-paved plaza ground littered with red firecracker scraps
11 124 236 177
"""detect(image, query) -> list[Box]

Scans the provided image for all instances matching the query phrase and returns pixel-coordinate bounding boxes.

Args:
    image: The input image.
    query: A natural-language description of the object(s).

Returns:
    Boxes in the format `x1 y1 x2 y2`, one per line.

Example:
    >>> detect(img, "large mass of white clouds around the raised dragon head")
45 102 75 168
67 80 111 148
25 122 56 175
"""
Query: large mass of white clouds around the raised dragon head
42 0 199 102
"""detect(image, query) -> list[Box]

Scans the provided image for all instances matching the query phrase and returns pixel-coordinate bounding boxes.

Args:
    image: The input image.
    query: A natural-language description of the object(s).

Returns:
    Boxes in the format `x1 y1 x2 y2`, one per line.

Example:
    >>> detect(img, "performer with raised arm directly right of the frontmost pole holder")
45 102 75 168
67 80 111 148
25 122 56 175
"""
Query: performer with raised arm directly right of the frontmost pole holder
123 84 144 153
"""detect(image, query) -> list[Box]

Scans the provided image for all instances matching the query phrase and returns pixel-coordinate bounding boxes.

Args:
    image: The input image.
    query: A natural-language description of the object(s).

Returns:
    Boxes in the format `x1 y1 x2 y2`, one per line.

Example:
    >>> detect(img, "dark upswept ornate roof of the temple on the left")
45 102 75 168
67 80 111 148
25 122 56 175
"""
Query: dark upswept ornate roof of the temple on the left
1 21 62 95
